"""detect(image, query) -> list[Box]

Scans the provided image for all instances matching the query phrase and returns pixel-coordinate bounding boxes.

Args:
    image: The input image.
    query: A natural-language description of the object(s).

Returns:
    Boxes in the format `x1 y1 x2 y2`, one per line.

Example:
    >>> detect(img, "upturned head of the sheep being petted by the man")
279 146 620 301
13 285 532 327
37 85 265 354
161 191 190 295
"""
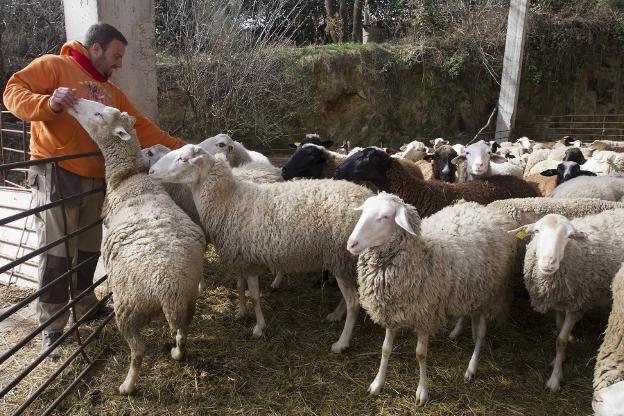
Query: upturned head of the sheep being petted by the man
68 98 134 145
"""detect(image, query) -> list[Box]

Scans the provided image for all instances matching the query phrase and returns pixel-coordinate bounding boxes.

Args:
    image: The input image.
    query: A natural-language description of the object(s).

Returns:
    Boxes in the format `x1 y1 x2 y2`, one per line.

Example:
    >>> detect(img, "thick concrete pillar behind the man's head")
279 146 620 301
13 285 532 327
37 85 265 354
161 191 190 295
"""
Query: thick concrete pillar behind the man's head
63 0 158 122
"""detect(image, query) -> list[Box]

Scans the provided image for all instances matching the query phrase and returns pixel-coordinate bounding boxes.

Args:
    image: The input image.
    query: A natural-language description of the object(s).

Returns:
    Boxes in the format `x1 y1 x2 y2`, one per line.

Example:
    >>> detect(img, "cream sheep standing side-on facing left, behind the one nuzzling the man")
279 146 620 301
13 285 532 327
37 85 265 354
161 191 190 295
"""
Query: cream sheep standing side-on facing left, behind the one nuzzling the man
150 145 372 353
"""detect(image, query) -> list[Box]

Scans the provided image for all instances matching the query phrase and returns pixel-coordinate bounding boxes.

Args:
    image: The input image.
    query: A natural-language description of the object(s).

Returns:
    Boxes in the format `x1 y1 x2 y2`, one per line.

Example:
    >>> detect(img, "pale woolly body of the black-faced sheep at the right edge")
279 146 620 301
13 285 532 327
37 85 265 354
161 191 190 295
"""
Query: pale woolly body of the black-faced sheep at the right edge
550 176 624 201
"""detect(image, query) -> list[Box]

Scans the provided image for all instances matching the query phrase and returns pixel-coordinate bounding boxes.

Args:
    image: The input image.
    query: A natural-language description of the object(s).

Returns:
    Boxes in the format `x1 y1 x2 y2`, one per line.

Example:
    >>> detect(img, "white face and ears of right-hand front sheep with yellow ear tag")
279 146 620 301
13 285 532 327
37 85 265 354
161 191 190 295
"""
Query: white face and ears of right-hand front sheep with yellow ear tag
512 214 587 275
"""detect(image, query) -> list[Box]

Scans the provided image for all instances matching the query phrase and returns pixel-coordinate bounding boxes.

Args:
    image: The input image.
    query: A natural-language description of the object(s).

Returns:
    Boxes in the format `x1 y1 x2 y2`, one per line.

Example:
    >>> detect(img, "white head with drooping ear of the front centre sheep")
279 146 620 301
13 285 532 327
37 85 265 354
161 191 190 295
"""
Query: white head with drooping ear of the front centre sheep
347 192 415 256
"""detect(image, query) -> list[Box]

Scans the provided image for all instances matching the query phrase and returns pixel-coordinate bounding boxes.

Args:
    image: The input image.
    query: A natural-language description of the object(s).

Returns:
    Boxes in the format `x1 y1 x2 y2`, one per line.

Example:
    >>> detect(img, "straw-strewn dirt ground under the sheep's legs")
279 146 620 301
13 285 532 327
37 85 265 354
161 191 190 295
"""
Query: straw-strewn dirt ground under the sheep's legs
9 247 606 416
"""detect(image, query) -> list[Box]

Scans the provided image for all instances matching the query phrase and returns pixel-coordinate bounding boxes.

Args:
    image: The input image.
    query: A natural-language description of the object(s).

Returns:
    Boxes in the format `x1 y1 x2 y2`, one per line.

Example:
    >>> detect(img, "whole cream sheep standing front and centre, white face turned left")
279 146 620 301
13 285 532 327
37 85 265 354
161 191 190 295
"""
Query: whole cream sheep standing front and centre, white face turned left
347 192 516 405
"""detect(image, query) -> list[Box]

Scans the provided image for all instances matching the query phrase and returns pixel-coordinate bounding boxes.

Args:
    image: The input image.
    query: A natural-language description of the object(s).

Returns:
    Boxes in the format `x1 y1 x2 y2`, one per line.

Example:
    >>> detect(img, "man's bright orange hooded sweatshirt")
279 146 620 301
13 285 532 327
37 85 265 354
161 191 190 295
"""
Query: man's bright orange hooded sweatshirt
3 41 184 178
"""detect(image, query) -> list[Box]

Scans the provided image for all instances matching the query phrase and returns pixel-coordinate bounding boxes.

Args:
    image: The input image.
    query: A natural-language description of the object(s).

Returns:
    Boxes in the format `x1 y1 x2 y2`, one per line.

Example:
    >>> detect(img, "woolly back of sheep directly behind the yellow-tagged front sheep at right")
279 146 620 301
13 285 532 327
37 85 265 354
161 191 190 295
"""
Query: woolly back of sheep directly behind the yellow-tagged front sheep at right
487 197 624 225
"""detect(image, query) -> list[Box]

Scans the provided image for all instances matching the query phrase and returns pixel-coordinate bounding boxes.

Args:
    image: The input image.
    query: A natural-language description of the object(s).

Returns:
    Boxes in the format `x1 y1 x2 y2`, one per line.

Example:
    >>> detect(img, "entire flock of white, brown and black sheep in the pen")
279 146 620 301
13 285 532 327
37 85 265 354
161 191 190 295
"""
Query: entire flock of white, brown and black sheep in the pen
70 100 624 415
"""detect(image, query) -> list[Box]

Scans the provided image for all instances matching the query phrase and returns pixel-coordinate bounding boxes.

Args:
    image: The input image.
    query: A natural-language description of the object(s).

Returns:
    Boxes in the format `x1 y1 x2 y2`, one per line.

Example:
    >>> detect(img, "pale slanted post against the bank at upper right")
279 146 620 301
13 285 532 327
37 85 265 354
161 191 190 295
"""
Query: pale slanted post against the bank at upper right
494 0 529 142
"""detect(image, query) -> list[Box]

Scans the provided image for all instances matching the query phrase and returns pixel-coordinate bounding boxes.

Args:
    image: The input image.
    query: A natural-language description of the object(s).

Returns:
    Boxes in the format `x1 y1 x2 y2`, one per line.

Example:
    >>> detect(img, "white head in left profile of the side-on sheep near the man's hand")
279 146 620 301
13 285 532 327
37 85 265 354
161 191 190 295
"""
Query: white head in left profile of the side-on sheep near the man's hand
149 144 215 184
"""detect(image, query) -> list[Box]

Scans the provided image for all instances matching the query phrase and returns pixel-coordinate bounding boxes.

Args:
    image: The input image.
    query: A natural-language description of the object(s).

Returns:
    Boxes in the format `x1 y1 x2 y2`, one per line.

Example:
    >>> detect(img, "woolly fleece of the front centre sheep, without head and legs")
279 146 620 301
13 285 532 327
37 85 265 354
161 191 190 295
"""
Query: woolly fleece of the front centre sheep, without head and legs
358 198 516 335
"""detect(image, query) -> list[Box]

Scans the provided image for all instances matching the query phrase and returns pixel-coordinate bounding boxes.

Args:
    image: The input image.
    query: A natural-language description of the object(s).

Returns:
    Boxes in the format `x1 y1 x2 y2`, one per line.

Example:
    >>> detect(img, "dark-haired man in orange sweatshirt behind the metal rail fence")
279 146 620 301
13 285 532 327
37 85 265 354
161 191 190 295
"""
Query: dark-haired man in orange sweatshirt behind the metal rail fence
3 23 184 358
